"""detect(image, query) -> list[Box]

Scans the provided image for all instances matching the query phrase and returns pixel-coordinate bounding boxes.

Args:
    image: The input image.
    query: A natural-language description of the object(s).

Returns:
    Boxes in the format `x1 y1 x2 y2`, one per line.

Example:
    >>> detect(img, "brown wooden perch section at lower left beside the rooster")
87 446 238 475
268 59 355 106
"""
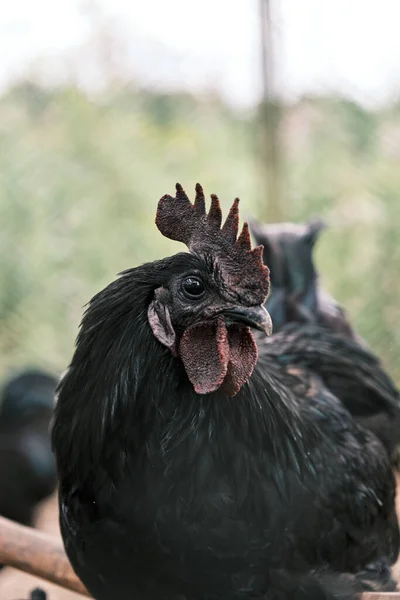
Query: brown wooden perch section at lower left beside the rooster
0 517 90 600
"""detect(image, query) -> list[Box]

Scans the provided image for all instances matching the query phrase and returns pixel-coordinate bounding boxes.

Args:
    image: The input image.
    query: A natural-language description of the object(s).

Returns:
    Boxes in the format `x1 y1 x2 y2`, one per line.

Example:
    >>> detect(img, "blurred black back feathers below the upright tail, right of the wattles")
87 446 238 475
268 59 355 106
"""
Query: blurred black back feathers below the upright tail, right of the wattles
264 323 400 465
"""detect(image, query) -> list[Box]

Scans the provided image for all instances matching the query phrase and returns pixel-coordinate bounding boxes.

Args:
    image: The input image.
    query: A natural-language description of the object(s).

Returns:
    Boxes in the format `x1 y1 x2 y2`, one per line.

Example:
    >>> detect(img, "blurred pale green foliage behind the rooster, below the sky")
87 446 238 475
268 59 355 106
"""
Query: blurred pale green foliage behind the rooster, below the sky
0 82 400 381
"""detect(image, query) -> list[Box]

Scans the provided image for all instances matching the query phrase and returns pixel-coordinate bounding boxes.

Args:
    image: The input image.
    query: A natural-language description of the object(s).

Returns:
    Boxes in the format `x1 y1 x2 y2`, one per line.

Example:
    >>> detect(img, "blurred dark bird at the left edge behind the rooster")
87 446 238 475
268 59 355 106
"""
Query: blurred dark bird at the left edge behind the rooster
0 370 58 525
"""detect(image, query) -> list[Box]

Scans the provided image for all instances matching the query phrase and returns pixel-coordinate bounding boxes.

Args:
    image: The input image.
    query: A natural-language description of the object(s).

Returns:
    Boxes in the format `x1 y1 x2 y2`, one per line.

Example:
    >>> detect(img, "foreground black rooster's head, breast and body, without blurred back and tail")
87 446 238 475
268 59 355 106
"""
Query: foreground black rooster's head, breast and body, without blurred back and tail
52 184 399 600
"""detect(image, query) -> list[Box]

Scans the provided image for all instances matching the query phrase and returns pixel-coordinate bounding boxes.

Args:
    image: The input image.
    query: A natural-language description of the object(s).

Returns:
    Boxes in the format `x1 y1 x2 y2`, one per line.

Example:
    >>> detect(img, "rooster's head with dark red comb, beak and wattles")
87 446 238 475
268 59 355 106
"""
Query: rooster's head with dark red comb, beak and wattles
148 184 272 396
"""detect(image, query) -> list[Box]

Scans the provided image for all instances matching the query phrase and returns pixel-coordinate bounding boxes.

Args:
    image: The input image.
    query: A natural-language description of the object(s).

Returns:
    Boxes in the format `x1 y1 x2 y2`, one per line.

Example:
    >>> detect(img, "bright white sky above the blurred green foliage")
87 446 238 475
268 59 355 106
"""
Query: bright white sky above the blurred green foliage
0 0 400 104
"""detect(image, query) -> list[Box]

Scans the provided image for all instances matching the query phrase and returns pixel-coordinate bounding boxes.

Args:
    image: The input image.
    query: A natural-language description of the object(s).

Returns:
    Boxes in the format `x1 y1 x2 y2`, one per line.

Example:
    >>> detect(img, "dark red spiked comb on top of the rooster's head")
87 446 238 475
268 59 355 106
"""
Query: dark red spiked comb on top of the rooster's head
156 183 269 304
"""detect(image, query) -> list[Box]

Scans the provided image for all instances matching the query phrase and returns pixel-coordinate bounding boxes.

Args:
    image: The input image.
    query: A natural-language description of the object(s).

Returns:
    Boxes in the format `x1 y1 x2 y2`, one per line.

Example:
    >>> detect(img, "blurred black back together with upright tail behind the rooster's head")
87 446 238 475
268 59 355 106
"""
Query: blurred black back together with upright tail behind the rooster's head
251 219 400 468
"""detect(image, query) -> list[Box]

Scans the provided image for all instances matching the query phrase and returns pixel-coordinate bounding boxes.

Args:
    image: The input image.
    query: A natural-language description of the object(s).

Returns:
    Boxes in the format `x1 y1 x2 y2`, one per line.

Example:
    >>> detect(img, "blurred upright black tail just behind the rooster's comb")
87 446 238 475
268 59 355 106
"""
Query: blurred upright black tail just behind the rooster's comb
251 219 361 341
